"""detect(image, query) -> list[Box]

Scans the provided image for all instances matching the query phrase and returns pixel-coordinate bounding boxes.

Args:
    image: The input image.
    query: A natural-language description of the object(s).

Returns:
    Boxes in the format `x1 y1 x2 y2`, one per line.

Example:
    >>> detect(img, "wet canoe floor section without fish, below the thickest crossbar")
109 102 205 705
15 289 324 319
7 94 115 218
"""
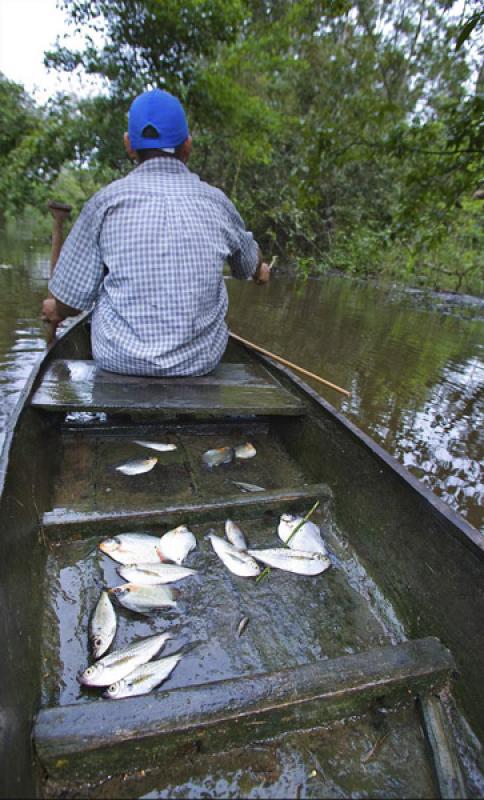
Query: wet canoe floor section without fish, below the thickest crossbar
44 708 438 798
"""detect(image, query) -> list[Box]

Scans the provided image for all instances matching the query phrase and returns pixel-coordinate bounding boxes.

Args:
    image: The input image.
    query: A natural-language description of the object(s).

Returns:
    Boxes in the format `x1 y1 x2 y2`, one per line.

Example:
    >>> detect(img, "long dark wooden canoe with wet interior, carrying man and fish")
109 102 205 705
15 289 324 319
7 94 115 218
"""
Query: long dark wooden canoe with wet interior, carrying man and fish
0 318 484 797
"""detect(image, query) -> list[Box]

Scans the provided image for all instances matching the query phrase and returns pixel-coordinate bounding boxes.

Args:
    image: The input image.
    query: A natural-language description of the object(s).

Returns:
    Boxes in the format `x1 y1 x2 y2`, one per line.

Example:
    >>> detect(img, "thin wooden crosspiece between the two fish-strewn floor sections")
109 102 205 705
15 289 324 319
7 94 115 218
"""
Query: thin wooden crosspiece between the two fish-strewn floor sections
42 483 332 540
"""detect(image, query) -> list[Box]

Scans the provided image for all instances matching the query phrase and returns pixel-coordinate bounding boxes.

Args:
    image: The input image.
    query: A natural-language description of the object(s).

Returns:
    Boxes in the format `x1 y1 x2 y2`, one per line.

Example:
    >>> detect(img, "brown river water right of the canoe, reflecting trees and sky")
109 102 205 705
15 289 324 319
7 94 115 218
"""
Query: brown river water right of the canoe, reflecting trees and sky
229 278 484 527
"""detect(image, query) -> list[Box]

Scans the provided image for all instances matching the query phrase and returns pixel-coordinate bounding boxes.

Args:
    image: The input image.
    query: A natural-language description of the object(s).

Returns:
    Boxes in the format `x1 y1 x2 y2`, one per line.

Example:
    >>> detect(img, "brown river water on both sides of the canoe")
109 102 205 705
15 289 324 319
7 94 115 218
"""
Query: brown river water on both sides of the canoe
0 238 484 529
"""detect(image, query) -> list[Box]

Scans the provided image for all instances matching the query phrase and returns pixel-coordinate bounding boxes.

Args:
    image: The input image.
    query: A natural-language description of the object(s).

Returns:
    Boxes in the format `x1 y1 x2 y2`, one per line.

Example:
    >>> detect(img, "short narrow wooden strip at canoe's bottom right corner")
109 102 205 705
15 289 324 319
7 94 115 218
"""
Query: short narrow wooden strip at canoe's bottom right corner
420 695 467 800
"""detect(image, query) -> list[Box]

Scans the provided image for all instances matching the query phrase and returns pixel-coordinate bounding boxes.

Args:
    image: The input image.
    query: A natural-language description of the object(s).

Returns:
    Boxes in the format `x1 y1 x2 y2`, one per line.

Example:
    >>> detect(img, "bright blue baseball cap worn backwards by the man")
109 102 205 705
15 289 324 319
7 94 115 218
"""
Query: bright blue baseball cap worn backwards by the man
128 89 189 152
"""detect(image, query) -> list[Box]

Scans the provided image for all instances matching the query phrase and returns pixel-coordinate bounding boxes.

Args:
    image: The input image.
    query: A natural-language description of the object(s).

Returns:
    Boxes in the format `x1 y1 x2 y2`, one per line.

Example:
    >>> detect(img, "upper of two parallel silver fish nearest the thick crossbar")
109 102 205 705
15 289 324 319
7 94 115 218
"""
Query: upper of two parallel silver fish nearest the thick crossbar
78 633 171 686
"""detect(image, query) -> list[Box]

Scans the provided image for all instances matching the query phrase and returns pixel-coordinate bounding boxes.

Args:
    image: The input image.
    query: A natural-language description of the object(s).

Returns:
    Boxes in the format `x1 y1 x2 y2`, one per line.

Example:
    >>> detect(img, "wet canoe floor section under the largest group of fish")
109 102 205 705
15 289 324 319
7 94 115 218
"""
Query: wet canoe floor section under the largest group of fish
38 509 390 706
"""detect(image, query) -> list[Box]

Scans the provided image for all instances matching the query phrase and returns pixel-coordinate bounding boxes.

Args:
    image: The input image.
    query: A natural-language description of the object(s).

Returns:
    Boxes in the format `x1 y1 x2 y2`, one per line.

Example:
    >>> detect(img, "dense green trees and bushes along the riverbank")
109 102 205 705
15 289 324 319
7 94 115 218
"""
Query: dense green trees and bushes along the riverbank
0 0 484 294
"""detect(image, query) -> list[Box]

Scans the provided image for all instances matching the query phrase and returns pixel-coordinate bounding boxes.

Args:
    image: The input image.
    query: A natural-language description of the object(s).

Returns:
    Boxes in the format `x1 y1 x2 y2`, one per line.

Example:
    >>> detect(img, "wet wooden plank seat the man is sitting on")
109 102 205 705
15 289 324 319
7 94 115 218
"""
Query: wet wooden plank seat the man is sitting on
32 359 304 416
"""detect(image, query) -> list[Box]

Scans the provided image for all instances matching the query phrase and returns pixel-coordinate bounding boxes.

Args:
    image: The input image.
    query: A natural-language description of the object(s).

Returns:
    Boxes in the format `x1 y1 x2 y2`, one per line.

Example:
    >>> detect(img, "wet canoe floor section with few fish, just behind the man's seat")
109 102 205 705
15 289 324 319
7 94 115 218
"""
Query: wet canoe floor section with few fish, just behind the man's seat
52 423 307 512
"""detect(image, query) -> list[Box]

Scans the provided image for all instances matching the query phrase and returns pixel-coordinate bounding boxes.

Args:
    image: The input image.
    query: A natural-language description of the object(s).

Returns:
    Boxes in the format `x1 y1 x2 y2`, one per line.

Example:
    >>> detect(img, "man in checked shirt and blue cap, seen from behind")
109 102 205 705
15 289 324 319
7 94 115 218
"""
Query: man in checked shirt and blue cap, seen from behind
42 89 270 375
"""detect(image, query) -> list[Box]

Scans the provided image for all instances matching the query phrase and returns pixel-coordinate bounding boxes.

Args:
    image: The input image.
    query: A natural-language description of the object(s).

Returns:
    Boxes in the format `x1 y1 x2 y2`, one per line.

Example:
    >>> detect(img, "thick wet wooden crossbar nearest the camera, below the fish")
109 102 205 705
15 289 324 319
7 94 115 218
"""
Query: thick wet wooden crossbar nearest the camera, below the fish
34 638 454 780
